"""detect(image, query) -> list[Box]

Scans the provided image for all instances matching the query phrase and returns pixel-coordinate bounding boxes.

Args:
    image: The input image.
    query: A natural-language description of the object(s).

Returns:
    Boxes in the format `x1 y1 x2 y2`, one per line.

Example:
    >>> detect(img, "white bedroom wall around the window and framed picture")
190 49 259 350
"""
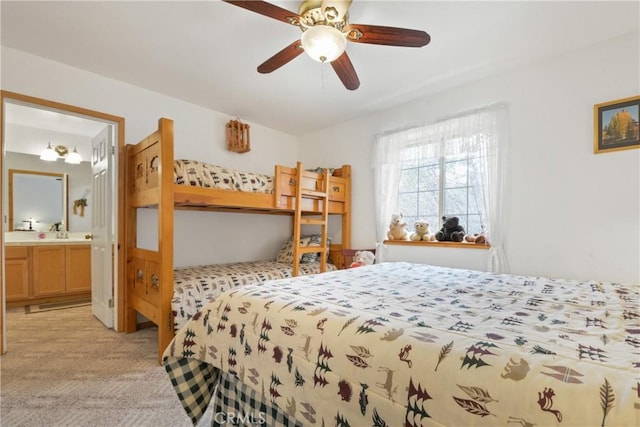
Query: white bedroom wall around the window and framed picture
301 33 640 283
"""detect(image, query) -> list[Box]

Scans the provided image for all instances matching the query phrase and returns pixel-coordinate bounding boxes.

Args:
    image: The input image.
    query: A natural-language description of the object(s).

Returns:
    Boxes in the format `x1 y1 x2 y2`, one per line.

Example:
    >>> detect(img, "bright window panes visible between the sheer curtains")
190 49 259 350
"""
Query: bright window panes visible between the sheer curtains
397 138 486 234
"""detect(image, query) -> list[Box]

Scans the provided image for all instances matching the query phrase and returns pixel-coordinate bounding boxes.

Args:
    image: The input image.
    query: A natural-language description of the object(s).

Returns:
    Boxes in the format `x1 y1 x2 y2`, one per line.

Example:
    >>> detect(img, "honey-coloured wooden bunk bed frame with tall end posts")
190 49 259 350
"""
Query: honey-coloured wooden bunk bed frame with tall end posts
124 118 351 362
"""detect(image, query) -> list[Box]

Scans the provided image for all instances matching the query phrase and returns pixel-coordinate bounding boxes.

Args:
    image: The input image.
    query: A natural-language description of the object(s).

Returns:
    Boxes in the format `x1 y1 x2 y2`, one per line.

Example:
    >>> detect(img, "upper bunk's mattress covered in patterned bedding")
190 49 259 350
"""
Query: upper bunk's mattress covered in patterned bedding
173 159 273 194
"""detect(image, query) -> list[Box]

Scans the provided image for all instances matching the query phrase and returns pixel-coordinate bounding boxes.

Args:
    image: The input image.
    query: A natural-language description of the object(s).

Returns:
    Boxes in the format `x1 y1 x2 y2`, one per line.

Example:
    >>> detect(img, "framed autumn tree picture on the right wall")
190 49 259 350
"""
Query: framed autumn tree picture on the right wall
593 96 640 154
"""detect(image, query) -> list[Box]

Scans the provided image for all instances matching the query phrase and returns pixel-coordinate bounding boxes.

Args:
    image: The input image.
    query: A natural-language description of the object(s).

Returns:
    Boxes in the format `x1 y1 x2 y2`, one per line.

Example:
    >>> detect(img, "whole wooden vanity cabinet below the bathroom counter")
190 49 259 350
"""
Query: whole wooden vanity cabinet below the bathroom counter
5 245 91 303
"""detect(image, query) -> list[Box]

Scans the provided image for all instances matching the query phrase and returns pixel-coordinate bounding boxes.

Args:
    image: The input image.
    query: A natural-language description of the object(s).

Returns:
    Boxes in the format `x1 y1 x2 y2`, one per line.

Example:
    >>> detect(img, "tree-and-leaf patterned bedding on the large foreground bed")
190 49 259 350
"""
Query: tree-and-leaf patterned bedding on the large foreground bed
164 263 640 427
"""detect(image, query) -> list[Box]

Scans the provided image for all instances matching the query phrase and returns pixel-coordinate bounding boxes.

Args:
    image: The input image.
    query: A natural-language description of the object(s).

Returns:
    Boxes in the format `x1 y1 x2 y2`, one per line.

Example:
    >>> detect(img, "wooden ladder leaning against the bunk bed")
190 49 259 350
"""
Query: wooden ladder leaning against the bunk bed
293 162 329 276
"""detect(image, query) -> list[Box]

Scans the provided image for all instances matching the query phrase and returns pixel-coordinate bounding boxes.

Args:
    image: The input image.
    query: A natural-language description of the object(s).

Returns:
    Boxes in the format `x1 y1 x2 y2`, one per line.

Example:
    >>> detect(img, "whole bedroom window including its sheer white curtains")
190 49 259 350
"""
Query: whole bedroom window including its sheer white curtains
373 105 507 272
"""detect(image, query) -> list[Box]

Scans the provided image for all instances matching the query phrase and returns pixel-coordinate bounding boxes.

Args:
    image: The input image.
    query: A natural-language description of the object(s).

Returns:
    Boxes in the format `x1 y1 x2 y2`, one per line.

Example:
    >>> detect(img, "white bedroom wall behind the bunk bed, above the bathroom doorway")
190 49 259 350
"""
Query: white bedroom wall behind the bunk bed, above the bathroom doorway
0 47 299 266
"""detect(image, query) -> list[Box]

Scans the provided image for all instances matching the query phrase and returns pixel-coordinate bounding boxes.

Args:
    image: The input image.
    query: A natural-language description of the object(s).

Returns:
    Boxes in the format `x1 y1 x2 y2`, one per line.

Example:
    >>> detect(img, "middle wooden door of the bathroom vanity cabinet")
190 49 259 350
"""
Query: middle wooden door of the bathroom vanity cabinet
33 245 66 297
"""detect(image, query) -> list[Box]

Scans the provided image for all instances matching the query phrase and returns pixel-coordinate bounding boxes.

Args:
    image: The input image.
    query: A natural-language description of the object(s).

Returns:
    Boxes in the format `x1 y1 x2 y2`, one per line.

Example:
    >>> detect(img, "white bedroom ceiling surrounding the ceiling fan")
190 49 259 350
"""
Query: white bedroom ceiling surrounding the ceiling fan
0 0 640 135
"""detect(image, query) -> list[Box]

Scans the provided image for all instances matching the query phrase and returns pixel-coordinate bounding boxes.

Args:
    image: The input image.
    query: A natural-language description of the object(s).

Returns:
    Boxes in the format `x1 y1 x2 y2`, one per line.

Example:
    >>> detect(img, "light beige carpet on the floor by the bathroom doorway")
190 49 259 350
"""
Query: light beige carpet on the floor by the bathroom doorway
0 306 211 427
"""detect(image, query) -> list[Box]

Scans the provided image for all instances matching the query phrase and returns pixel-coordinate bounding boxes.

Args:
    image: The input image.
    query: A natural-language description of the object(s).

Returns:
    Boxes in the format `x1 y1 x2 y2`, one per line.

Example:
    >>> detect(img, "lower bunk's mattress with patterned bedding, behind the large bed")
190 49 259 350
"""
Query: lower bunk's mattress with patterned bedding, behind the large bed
171 261 336 331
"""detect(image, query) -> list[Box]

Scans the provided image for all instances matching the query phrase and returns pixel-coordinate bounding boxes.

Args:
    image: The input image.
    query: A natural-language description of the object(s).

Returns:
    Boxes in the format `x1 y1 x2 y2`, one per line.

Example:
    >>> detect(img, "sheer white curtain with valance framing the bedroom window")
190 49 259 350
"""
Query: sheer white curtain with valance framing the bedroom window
373 105 508 272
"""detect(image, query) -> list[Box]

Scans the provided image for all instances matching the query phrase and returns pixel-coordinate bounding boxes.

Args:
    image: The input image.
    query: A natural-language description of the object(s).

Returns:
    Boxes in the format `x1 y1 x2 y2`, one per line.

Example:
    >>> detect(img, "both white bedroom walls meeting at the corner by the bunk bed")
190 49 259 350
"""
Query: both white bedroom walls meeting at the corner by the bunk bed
0 33 640 282
